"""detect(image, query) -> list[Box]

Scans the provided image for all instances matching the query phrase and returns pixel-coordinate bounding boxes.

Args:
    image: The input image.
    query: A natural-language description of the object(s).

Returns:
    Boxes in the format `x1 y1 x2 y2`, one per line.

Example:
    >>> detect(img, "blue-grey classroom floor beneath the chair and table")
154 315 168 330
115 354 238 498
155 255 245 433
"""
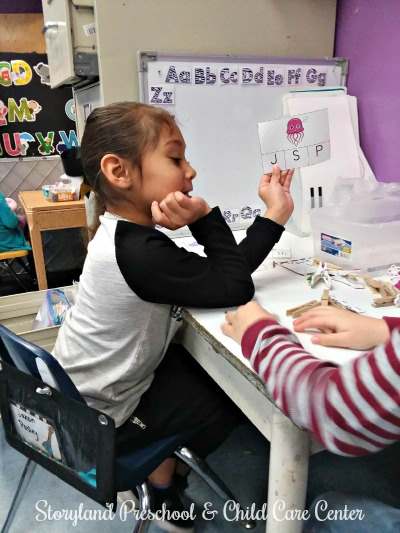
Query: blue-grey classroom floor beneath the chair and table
0 421 268 533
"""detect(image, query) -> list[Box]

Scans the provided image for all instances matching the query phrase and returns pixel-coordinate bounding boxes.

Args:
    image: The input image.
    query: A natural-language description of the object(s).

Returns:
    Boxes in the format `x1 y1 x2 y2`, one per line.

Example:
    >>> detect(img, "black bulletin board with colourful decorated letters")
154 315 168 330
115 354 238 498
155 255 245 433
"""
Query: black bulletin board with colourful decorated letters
0 52 78 158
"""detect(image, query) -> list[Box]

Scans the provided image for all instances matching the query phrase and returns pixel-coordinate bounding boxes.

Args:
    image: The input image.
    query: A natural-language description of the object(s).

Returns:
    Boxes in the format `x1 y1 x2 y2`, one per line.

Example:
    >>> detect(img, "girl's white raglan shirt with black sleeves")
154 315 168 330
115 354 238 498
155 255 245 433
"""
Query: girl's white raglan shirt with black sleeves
53 208 284 427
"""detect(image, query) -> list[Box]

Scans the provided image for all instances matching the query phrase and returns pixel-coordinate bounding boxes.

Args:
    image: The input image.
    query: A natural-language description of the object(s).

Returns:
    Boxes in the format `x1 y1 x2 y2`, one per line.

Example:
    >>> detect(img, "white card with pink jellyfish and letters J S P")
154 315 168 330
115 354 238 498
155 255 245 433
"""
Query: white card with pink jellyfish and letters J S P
258 109 331 173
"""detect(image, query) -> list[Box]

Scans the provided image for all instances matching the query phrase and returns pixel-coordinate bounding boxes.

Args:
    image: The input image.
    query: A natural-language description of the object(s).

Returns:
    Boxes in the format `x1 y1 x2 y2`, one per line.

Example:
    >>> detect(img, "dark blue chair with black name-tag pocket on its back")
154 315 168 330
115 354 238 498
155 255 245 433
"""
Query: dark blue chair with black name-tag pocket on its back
0 325 255 533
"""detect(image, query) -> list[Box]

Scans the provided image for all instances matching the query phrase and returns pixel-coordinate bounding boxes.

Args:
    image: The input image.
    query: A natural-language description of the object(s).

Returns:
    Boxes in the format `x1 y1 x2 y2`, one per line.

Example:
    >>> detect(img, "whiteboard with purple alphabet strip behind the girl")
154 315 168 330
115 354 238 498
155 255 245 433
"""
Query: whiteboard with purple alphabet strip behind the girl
138 52 347 234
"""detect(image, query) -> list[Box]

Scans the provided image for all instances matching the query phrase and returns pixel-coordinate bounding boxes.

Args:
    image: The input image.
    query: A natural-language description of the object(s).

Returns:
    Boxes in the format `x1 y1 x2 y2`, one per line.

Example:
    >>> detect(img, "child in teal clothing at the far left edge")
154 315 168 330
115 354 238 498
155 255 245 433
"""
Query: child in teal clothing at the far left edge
0 192 31 252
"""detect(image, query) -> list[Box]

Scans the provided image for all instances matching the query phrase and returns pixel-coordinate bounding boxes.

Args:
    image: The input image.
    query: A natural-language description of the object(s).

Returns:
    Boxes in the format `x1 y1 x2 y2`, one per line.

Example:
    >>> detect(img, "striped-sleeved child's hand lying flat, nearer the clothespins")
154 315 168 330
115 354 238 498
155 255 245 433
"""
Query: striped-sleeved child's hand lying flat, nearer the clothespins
293 306 390 350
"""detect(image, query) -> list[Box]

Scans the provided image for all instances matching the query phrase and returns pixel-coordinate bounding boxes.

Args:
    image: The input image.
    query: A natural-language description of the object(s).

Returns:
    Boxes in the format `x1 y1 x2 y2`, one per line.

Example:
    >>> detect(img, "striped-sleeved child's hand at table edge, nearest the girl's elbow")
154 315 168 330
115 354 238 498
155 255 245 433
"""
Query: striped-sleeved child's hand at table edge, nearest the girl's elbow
221 300 276 344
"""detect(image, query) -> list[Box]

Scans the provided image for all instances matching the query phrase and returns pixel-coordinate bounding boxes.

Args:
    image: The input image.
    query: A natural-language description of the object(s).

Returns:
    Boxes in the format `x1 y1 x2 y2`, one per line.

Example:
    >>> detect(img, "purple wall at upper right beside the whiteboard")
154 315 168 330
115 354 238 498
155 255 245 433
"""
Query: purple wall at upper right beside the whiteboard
335 0 400 181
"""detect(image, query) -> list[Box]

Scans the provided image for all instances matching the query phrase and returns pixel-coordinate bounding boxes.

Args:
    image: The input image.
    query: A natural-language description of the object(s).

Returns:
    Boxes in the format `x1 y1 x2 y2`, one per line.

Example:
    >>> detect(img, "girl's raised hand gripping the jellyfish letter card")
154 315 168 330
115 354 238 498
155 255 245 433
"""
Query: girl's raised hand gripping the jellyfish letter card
258 165 294 226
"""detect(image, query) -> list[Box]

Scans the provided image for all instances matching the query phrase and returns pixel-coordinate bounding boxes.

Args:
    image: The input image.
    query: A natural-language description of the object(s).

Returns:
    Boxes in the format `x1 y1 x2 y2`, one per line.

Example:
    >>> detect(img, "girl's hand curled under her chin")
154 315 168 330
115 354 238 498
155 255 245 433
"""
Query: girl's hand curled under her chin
151 191 211 230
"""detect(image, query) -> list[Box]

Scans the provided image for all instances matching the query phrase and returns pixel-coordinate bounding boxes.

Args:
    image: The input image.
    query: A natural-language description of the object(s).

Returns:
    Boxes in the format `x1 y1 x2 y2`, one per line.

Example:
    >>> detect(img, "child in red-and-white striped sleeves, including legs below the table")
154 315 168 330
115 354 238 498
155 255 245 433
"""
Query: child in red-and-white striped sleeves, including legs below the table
222 301 400 533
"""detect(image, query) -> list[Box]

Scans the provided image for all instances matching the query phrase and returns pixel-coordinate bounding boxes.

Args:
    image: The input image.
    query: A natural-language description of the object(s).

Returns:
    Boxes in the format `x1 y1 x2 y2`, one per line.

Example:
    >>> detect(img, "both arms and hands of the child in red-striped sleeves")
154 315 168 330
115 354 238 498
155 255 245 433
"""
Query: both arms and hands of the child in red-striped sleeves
222 301 400 455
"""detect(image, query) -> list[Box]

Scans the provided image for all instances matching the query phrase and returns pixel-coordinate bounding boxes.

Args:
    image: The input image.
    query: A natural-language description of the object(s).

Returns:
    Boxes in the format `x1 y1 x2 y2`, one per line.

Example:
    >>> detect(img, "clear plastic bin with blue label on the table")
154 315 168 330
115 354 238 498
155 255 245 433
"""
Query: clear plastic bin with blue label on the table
311 193 400 270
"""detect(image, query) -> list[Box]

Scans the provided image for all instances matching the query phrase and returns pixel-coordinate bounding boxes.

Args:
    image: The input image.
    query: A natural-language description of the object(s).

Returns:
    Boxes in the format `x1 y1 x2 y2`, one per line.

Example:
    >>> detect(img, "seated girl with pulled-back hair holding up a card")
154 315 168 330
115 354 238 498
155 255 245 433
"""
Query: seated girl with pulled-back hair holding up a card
54 102 293 531
